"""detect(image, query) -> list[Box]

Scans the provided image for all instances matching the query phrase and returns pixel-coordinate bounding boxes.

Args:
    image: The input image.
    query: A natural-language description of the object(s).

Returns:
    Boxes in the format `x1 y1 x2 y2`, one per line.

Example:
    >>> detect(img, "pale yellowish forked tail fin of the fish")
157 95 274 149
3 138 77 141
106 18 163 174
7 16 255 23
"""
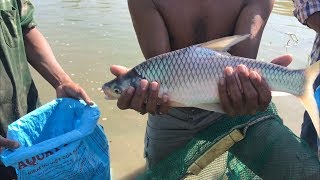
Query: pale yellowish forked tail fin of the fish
299 61 320 157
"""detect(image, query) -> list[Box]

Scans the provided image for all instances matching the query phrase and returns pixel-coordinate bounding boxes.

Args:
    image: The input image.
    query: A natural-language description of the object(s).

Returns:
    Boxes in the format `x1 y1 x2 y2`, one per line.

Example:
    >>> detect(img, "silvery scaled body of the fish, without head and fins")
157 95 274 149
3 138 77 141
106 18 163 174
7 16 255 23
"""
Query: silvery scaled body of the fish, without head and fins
134 46 305 105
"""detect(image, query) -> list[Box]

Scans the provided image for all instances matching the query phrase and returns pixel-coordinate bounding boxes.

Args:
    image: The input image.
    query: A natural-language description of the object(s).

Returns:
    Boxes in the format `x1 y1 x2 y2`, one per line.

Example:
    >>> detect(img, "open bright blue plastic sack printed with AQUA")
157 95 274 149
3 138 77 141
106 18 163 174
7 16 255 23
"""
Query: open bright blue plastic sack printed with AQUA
1 98 110 180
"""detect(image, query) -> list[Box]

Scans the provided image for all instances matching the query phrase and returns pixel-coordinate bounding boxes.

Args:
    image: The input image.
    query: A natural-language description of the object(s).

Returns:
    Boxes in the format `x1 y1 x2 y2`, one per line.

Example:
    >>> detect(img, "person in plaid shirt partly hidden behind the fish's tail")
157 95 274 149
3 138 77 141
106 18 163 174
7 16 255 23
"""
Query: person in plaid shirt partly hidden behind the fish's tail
293 0 320 152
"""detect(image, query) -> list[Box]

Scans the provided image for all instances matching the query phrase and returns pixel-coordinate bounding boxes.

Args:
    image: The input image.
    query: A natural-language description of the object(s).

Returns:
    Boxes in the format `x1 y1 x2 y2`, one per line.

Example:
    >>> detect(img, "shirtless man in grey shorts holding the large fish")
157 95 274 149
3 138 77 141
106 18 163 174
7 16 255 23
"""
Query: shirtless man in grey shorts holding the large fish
111 0 298 167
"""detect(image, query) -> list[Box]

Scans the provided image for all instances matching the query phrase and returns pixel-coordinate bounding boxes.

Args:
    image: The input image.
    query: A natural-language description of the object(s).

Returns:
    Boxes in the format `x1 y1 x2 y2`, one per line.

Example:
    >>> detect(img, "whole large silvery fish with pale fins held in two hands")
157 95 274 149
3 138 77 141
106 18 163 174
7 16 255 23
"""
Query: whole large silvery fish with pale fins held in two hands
102 35 320 158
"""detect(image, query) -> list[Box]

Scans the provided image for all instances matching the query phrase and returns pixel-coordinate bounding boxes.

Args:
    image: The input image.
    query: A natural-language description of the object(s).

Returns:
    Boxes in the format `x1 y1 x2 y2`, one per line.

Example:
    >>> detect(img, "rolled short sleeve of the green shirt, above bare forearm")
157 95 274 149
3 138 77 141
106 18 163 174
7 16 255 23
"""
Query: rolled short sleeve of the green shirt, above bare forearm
20 0 36 32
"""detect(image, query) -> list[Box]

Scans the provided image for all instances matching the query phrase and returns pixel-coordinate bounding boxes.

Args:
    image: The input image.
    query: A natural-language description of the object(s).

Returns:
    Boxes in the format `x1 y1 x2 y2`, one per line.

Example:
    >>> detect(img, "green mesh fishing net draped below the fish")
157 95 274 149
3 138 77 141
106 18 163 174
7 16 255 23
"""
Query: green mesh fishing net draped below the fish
138 104 320 180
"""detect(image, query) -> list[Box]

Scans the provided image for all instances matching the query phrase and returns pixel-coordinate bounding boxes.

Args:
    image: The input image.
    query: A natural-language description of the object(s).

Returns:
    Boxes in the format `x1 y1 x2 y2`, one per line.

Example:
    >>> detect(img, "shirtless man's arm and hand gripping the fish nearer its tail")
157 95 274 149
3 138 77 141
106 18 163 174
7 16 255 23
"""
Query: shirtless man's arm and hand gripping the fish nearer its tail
218 0 274 116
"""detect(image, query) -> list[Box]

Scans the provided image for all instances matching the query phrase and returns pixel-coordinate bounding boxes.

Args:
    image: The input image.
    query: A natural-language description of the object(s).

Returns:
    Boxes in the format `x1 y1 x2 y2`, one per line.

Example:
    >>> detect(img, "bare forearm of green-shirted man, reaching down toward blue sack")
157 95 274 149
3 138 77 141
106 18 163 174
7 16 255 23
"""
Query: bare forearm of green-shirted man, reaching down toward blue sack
24 28 71 89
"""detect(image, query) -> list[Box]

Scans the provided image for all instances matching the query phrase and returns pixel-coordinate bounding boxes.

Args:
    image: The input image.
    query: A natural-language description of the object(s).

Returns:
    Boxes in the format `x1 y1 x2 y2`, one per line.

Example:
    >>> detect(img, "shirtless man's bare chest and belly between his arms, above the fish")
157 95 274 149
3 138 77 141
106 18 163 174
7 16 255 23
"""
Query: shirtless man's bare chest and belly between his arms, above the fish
154 0 245 50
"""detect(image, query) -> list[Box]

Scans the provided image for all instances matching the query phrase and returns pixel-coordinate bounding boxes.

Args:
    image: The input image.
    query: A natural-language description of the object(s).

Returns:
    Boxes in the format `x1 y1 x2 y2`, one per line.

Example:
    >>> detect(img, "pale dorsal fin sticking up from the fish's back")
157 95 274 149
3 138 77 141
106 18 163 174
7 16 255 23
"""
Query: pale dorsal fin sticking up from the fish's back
200 34 250 52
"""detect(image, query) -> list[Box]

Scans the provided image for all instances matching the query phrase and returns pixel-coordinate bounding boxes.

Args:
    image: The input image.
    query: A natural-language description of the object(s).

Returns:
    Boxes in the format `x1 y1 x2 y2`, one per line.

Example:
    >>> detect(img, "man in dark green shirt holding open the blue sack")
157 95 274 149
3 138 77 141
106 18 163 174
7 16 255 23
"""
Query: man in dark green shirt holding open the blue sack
0 0 92 179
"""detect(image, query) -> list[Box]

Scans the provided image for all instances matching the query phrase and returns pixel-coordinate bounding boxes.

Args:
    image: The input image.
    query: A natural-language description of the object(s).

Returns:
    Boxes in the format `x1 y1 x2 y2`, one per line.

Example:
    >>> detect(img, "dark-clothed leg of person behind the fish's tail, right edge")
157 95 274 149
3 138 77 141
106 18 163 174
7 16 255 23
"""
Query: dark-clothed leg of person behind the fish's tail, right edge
300 76 320 152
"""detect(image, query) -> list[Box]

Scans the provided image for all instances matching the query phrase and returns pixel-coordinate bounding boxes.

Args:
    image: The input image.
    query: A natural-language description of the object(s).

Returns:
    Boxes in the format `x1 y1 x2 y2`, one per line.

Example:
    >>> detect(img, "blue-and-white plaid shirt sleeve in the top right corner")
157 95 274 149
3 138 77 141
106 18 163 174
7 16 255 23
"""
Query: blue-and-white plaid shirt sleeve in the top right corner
293 0 320 25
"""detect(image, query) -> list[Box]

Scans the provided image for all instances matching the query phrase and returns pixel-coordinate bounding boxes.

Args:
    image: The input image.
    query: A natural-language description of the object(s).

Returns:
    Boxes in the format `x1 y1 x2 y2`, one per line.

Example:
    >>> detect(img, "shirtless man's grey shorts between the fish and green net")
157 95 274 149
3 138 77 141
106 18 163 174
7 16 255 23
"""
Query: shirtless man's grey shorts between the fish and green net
145 108 221 168
